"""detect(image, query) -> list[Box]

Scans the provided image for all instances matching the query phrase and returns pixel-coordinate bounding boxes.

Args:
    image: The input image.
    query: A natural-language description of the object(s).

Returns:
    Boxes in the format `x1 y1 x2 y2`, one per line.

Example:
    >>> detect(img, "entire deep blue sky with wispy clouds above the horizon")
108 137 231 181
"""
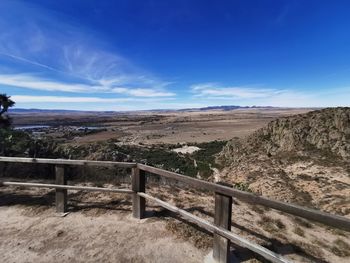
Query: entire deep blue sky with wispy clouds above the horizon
0 0 350 110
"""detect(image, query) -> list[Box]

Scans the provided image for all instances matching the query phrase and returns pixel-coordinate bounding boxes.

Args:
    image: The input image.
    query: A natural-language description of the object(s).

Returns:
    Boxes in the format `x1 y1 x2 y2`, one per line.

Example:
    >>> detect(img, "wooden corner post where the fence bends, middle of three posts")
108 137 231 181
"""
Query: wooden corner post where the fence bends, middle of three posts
131 168 146 219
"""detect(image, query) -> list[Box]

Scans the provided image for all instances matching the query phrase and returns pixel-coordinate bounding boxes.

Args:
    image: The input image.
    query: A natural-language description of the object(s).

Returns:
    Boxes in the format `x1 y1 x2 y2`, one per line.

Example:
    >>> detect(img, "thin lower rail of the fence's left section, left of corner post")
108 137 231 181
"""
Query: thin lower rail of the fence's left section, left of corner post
0 182 133 194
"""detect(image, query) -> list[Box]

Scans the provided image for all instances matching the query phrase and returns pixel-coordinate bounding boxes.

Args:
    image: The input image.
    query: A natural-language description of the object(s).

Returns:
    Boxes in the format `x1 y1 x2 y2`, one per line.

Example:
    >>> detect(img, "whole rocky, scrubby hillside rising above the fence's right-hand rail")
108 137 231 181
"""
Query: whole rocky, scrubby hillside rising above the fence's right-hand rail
218 108 350 216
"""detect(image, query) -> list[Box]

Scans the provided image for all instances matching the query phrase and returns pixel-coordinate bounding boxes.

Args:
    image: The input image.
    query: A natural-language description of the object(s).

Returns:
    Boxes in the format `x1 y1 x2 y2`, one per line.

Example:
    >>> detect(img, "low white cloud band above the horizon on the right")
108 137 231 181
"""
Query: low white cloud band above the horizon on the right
191 83 350 107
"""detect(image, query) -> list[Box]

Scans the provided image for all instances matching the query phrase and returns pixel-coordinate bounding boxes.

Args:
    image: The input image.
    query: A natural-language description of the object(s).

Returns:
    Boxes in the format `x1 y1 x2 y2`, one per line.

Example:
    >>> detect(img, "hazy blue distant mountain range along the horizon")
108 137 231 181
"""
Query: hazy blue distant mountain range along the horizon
9 105 275 114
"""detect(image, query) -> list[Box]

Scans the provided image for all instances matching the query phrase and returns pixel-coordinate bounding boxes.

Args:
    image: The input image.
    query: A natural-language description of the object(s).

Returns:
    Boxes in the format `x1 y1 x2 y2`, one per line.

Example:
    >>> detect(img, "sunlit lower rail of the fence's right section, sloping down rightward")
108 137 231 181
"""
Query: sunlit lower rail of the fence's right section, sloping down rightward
137 193 291 263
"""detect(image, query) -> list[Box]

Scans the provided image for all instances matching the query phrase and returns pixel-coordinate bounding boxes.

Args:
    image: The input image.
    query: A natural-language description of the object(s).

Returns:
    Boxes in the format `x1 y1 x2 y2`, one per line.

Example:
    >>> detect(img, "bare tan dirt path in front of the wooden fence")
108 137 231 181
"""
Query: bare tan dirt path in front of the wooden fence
0 205 205 263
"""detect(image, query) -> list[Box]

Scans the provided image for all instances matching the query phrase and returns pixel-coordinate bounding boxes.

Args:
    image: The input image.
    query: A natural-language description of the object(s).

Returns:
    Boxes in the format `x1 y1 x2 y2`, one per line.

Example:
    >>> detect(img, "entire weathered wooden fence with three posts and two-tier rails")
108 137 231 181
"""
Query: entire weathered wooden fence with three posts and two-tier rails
0 157 350 262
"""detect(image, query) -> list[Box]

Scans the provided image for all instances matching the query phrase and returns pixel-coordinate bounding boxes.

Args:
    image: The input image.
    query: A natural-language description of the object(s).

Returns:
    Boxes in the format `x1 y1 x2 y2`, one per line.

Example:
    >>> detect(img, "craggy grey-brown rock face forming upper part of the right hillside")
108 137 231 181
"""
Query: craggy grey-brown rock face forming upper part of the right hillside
222 108 350 163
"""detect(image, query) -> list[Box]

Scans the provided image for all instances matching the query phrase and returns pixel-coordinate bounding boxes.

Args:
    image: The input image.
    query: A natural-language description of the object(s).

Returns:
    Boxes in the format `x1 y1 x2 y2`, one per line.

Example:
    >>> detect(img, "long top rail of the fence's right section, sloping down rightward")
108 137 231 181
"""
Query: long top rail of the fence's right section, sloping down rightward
137 164 350 231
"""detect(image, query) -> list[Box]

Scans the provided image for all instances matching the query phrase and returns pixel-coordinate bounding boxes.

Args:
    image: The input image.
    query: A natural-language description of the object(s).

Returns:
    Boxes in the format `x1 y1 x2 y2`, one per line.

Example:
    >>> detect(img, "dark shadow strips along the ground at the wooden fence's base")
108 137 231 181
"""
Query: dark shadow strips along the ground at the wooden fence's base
0 190 327 263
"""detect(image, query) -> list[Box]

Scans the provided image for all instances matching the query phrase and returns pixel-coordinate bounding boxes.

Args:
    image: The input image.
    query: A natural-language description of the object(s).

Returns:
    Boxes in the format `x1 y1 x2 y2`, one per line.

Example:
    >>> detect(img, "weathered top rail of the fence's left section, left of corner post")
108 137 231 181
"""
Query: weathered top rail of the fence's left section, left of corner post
0 156 136 168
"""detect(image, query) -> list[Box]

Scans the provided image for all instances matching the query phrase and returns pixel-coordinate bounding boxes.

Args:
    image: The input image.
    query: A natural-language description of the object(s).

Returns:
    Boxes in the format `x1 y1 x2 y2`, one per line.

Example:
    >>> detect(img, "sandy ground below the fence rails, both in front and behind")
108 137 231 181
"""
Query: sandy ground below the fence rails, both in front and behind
0 185 350 263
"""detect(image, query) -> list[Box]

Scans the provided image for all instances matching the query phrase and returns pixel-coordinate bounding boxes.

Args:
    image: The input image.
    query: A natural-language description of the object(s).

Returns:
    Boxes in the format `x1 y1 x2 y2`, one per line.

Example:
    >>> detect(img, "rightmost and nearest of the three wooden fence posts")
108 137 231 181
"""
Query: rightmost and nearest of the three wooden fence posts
213 183 232 263
